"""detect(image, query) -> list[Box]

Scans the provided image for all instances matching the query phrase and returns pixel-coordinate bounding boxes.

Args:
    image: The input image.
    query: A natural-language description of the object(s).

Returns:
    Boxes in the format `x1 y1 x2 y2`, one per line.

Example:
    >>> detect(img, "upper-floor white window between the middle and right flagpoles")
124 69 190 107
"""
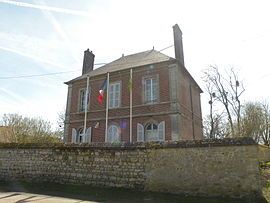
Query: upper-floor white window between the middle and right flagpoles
109 82 121 108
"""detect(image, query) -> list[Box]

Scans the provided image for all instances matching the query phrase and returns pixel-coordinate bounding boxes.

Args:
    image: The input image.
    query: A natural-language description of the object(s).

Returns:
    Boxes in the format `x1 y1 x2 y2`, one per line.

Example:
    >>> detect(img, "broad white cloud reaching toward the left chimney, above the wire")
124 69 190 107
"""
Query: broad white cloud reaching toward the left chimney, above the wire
0 32 79 72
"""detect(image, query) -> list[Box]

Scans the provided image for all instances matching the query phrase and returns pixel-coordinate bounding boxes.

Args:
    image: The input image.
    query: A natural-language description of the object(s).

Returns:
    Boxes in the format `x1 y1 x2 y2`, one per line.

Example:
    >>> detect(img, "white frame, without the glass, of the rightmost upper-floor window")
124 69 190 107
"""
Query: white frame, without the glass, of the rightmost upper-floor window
143 75 159 104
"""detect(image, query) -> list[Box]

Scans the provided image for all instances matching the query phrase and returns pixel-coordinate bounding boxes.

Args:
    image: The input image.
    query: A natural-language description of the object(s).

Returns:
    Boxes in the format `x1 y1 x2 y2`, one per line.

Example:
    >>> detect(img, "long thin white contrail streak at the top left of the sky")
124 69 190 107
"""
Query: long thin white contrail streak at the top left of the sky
0 0 90 17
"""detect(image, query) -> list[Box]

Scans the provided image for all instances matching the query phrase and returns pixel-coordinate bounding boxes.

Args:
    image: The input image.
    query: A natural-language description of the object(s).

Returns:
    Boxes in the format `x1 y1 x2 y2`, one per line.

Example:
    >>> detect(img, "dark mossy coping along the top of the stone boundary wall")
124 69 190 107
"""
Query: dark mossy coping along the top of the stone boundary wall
0 137 257 150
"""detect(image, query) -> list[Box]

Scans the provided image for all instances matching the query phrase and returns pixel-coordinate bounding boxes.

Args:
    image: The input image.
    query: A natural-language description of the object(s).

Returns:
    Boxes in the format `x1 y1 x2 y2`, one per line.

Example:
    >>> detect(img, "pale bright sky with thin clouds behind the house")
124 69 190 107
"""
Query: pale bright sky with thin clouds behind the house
0 0 270 128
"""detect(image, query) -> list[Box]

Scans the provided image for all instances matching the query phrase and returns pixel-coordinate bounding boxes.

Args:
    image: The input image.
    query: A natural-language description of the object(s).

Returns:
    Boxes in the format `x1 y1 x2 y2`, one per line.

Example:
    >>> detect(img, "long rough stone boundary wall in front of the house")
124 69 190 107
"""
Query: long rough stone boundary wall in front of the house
0 138 261 197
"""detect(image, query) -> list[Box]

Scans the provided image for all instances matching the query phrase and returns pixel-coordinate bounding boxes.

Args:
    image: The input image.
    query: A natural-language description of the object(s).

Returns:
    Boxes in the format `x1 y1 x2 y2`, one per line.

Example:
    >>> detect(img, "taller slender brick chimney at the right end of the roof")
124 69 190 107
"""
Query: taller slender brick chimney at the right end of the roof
173 24 185 66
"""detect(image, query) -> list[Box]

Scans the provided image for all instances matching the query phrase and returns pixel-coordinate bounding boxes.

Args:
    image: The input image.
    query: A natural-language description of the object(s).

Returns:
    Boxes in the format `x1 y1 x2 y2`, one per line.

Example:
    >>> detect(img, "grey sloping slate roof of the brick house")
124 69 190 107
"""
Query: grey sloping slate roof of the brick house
66 49 173 84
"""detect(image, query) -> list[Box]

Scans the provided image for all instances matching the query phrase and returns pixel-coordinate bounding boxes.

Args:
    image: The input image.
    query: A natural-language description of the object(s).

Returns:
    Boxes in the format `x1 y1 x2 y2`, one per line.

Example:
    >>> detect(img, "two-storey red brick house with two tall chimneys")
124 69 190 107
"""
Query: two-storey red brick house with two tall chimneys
64 25 202 143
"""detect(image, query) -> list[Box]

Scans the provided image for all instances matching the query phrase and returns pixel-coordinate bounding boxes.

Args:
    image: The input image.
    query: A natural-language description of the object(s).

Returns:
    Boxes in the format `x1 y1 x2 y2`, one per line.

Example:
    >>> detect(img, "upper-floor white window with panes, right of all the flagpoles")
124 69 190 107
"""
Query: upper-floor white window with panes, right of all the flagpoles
144 77 158 103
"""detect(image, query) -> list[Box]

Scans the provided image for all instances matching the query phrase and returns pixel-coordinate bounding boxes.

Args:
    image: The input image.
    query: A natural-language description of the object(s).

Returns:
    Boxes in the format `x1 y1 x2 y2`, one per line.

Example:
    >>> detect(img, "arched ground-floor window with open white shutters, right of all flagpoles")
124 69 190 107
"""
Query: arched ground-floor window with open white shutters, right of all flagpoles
137 121 165 142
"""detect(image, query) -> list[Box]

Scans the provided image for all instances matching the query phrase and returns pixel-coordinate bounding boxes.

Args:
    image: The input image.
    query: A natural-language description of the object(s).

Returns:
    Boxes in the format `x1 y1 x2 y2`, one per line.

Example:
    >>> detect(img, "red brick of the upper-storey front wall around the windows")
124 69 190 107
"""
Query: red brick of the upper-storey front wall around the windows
70 62 170 115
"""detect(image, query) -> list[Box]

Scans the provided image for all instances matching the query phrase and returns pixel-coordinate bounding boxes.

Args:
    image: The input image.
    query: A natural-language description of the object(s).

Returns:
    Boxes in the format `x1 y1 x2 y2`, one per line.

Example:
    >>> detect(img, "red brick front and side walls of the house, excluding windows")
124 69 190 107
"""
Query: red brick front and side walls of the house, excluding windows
67 61 202 142
